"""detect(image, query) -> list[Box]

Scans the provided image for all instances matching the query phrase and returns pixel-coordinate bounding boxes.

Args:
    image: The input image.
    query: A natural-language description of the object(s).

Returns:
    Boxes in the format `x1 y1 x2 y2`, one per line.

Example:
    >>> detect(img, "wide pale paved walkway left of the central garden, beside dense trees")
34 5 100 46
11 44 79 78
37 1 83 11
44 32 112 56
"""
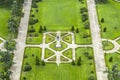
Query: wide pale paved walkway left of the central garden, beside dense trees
11 0 32 80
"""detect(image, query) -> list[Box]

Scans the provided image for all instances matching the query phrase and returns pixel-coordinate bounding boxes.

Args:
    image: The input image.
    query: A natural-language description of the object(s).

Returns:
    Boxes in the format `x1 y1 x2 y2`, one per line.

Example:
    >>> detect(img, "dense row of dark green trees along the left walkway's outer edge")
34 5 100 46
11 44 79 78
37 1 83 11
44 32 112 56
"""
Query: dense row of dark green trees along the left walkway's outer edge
0 0 24 80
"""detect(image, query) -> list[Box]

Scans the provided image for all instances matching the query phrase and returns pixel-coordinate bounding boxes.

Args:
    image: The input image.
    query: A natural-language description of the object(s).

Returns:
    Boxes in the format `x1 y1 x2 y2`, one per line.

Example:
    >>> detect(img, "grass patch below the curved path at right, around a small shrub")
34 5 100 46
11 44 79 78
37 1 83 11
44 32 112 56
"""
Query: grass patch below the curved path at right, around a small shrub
105 53 120 69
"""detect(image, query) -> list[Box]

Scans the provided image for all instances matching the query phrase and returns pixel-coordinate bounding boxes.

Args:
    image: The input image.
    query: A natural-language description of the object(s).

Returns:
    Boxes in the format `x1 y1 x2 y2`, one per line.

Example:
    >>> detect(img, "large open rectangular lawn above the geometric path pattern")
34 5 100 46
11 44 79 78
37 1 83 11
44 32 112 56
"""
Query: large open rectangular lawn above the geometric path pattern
34 0 80 30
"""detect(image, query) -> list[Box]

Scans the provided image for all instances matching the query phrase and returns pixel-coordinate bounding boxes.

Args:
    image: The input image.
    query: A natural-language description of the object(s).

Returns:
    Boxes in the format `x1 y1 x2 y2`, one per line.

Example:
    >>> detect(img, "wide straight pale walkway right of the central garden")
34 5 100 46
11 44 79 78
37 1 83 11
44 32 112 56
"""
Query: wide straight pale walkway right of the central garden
87 0 108 80
